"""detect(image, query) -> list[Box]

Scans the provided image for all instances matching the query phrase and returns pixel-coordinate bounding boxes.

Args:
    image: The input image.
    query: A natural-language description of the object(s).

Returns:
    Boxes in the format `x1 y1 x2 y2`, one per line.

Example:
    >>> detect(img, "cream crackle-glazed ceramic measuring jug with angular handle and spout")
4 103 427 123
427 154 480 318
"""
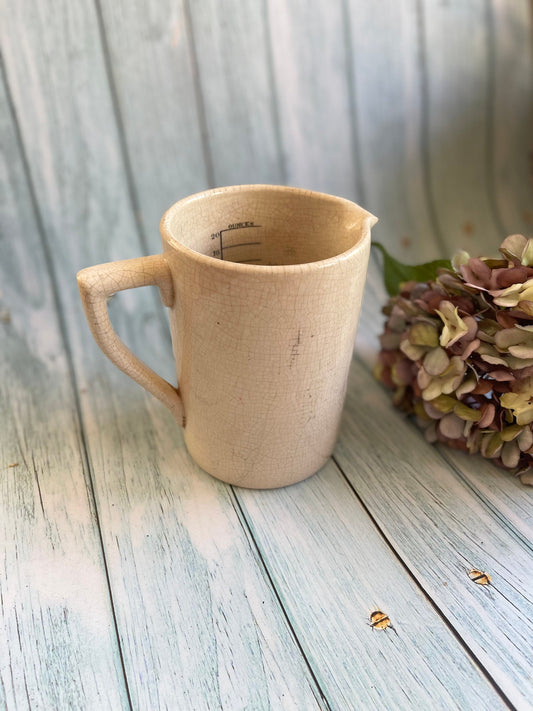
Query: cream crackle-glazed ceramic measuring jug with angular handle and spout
78 185 376 488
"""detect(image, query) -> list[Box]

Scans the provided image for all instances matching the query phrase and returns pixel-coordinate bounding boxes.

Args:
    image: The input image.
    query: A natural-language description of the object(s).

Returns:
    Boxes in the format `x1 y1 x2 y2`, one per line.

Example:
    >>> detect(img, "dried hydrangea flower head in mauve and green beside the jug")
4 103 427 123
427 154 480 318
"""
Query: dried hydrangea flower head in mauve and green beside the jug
375 235 533 474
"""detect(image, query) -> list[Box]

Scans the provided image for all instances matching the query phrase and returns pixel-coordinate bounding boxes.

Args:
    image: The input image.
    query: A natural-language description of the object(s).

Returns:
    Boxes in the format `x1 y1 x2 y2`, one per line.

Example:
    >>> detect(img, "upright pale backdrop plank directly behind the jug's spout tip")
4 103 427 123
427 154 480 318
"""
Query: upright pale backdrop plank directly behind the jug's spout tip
347 0 444 263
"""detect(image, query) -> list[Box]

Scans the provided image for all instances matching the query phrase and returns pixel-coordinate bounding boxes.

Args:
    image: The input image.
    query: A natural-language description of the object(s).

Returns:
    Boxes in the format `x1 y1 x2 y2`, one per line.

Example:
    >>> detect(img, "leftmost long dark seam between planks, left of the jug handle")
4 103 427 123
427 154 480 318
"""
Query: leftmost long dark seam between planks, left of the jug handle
0 61 133 709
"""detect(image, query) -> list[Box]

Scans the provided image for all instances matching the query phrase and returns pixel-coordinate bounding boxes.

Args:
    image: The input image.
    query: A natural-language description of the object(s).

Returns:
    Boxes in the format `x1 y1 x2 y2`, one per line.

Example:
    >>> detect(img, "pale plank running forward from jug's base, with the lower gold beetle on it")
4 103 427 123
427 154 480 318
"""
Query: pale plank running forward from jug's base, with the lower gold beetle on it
237 462 505 711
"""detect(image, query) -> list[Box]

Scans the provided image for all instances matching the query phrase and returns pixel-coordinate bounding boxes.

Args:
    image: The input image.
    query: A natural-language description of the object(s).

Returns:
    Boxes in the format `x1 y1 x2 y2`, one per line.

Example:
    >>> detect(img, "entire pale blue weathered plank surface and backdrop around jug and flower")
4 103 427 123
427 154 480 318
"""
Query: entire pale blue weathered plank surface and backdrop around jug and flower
0 0 533 711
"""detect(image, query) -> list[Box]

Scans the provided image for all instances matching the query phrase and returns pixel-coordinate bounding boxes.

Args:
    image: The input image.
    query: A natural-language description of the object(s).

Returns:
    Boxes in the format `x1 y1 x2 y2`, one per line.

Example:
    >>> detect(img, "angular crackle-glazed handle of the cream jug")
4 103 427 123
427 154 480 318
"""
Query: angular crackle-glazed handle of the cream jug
77 254 185 427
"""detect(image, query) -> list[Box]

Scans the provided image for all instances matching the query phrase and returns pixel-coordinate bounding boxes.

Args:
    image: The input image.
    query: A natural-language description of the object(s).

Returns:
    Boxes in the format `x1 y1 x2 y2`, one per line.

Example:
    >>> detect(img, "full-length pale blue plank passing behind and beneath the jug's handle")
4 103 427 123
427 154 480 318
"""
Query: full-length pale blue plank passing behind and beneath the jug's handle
0 2 325 711
